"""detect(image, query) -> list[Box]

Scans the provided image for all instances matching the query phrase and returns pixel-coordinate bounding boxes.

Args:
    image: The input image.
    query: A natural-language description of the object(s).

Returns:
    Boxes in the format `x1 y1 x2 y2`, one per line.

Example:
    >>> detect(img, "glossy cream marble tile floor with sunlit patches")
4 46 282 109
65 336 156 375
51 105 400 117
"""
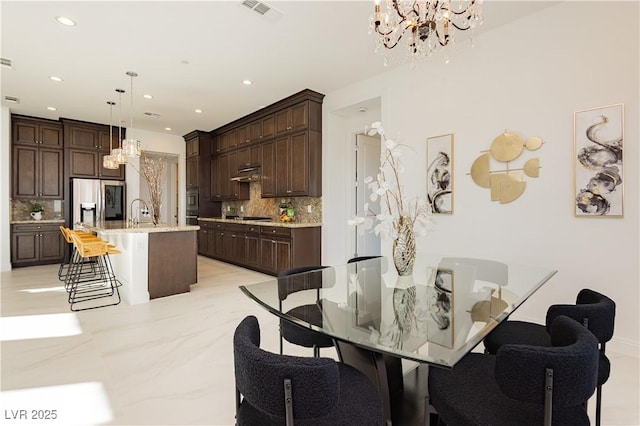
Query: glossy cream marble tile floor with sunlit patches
0 257 640 426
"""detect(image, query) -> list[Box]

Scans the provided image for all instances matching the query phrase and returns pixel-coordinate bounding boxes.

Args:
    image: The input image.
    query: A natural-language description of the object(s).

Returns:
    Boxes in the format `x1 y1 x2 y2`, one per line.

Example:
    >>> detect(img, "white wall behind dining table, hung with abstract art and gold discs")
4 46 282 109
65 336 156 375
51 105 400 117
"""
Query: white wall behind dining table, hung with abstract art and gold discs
323 2 640 354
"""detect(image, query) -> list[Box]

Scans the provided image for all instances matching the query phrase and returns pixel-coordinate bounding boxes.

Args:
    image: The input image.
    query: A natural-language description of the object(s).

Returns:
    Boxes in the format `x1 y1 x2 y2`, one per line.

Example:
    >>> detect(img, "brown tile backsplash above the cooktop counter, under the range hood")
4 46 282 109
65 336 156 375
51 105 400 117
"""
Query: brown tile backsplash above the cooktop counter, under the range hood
222 182 322 223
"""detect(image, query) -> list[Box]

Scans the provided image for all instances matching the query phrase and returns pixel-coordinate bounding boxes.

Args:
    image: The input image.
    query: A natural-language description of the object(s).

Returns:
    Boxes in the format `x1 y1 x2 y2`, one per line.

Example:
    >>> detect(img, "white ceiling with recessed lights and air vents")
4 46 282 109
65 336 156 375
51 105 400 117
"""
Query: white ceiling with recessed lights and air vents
0 0 553 136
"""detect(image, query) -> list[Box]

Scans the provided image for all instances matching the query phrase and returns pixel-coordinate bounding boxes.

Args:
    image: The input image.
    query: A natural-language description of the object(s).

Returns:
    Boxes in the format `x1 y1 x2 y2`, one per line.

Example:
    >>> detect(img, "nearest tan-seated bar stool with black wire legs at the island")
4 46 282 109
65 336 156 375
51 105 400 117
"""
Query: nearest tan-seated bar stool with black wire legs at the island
65 230 122 311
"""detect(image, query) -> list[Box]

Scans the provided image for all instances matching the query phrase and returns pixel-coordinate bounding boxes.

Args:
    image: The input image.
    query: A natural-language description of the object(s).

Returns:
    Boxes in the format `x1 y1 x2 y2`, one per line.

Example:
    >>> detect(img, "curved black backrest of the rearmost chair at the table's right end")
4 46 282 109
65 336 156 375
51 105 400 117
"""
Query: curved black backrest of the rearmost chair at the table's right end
546 288 616 343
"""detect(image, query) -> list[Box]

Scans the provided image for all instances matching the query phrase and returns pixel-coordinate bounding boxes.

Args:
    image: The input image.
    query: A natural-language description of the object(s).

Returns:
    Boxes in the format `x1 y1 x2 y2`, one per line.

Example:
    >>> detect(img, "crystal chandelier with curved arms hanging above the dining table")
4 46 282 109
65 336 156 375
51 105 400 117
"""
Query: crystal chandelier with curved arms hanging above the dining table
369 0 482 65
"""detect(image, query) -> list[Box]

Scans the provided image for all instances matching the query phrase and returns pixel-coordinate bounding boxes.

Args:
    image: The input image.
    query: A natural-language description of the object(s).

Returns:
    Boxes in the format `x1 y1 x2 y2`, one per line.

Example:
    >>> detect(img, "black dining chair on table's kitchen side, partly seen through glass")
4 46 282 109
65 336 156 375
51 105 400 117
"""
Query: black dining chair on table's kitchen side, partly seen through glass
278 266 335 357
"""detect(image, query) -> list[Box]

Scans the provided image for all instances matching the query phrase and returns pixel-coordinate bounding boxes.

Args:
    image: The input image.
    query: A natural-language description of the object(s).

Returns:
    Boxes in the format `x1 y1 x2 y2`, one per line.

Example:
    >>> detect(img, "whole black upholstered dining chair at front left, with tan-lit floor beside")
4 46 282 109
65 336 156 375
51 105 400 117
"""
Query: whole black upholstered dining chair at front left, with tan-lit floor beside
233 316 383 426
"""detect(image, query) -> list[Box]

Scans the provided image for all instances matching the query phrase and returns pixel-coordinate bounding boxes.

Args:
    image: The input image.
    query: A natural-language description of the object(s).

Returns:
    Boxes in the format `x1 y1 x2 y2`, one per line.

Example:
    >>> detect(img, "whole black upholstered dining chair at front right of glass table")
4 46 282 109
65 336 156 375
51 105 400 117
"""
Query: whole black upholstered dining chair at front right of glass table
429 316 598 426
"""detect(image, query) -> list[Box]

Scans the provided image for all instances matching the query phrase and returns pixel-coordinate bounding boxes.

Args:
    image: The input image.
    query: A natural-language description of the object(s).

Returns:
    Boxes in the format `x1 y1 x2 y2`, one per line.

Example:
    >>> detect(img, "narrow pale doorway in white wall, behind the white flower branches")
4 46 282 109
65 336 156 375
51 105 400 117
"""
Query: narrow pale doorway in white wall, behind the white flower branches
354 133 381 256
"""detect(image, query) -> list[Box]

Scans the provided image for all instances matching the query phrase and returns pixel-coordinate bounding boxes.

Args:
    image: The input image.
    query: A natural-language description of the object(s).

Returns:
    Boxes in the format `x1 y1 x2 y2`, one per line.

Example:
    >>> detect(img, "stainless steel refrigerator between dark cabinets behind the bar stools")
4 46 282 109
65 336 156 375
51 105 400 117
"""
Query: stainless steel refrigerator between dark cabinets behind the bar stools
71 178 127 227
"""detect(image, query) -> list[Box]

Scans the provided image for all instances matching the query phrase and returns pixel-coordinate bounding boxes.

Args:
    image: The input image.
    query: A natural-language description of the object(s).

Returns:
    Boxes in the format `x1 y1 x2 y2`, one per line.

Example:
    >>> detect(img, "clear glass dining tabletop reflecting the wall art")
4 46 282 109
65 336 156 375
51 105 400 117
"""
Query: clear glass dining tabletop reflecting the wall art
240 256 556 367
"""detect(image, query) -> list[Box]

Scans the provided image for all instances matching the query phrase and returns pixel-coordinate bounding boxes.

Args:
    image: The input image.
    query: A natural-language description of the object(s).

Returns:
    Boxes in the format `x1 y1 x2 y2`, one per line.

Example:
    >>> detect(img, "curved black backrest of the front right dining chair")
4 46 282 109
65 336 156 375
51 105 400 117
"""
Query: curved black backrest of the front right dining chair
495 315 598 408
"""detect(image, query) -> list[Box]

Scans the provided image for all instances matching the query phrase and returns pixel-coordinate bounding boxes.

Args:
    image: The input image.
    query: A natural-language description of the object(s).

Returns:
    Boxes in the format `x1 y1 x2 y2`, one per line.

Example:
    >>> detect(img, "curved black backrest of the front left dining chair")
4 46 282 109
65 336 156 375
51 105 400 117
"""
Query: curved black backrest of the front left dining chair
233 316 340 419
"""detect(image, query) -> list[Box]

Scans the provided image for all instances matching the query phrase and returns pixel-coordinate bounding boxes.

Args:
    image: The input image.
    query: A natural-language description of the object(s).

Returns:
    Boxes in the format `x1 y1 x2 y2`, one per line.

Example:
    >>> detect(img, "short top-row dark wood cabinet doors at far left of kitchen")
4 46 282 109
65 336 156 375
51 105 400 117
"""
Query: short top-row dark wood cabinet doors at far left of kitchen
11 115 62 148
